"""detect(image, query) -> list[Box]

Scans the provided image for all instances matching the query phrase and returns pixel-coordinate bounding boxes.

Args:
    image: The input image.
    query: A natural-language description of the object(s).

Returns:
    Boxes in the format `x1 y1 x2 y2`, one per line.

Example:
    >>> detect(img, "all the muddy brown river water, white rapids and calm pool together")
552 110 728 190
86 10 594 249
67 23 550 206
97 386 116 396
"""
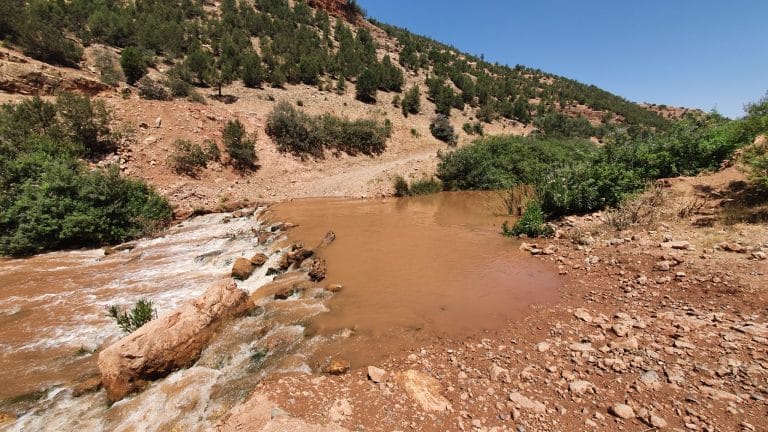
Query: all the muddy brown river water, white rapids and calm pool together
0 193 558 431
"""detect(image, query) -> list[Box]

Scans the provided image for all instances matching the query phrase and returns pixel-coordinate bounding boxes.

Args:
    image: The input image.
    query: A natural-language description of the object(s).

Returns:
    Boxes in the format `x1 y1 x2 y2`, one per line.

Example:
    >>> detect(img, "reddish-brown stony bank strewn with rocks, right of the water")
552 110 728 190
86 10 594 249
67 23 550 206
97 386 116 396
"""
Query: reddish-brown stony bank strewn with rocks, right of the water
219 172 768 431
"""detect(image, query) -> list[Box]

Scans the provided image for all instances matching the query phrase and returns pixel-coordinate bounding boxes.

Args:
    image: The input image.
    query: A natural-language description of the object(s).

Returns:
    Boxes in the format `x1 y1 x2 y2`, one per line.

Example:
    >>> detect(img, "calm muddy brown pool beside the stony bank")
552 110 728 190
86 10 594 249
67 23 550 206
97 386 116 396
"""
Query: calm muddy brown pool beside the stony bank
272 192 560 366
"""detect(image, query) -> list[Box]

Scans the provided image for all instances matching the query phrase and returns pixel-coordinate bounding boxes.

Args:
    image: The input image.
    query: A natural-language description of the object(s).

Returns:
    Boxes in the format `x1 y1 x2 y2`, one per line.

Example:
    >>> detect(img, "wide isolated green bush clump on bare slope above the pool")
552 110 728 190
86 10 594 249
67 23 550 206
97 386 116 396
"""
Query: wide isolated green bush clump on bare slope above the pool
267 102 392 158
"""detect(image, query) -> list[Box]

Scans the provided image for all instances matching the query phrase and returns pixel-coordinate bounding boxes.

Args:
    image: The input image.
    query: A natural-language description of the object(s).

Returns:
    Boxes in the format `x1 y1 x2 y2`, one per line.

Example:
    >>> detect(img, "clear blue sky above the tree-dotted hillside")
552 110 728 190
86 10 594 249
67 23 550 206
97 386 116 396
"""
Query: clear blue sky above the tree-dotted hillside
358 0 768 118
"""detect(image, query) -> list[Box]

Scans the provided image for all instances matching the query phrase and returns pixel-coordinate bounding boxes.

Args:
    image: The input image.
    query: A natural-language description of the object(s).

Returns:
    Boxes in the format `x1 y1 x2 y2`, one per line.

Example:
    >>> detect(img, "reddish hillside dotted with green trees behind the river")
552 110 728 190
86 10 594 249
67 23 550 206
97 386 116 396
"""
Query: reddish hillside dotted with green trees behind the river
0 0 666 215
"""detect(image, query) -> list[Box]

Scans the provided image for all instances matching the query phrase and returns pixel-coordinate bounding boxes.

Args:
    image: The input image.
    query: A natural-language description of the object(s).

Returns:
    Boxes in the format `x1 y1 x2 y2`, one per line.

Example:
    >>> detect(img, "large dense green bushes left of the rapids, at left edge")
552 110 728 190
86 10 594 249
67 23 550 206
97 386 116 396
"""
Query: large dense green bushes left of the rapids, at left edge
0 95 171 255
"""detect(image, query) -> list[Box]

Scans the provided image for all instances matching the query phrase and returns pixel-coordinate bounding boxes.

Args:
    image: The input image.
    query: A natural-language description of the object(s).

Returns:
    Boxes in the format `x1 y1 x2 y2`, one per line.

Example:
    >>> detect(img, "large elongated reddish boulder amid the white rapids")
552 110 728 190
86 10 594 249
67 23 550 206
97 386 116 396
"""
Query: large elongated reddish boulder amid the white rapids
98 280 250 401
